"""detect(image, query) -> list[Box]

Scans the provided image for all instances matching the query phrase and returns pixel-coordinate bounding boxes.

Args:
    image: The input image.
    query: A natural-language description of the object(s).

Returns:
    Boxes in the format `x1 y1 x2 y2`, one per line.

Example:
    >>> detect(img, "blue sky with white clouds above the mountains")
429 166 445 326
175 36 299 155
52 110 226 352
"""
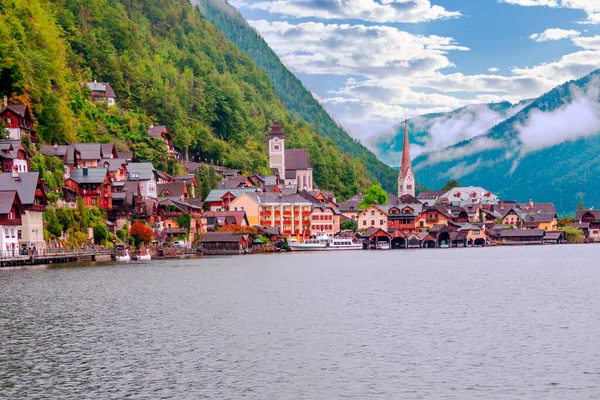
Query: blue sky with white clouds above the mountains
229 0 600 142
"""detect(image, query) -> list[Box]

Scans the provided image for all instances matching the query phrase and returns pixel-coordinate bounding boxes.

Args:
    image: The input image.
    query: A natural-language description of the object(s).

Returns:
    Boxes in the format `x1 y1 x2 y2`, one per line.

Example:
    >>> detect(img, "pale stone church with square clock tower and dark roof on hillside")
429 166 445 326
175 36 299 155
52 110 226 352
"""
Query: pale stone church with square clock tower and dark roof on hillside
269 121 313 190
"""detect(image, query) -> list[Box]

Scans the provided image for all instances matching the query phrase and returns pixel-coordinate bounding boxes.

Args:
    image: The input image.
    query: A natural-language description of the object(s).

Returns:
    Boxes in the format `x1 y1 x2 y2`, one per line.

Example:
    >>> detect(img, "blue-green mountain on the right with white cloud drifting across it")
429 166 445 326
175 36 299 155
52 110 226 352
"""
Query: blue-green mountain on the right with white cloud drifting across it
414 70 600 215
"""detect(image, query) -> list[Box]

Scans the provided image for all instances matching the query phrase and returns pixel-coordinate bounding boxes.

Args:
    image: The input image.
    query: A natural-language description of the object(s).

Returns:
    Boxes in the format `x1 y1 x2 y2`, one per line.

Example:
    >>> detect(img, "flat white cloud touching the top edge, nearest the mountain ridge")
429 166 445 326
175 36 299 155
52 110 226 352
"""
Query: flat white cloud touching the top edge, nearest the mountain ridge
245 0 461 23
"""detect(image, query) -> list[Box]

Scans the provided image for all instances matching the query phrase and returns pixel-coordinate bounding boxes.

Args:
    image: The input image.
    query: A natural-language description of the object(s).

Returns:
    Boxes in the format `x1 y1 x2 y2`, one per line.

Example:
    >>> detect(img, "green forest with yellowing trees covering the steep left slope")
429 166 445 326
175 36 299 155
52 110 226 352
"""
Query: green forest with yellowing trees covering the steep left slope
0 0 378 199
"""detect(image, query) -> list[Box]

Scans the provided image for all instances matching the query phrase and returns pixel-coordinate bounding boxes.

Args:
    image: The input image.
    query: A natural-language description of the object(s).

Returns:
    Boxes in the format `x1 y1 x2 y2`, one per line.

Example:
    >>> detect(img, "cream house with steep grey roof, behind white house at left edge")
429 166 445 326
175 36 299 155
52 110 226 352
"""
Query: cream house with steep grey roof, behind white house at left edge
0 169 48 249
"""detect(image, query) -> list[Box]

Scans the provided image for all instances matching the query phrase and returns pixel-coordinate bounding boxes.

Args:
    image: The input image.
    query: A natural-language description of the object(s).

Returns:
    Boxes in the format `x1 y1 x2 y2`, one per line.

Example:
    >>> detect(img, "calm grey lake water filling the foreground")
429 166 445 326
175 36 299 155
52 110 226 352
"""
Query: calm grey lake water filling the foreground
0 245 600 400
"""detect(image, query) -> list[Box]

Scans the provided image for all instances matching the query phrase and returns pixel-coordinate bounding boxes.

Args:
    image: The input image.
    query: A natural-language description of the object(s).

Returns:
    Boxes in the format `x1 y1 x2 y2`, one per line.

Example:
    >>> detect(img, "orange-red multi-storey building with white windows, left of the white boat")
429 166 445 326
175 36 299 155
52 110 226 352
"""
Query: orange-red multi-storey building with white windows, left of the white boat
259 194 313 239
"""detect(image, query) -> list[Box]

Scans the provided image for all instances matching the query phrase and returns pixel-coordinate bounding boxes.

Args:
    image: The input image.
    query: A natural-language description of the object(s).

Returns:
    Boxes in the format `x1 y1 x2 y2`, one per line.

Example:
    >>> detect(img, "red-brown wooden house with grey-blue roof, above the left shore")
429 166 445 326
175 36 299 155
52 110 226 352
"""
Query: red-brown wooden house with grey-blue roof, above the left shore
65 168 112 210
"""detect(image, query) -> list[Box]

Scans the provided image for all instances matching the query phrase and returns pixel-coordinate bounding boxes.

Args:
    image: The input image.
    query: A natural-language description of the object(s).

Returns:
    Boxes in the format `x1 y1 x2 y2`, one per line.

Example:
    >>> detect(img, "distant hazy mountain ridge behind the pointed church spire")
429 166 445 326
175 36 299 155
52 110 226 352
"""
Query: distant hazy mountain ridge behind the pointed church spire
369 100 531 166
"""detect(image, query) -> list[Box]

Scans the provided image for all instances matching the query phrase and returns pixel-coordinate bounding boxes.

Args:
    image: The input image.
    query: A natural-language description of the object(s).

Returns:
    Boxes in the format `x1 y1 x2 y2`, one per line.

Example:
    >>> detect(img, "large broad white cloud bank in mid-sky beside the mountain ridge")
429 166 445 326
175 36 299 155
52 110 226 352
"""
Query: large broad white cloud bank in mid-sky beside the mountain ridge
250 20 468 78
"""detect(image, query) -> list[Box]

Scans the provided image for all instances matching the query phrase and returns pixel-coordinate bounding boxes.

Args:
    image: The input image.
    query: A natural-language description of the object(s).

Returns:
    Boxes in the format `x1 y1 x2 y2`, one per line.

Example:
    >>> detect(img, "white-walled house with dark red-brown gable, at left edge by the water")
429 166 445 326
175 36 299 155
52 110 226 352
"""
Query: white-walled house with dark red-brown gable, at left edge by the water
0 190 25 257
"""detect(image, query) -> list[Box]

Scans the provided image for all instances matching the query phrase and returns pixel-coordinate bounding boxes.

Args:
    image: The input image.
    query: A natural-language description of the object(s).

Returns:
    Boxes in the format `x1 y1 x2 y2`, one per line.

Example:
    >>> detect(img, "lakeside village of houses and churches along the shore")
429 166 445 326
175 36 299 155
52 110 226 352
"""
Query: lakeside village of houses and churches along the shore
0 81 600 261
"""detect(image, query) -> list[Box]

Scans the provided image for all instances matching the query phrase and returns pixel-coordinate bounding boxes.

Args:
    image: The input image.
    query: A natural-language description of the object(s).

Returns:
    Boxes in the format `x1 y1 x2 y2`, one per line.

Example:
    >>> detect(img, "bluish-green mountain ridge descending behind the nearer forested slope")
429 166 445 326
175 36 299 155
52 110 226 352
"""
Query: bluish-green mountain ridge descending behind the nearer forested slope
192 0 408 193
